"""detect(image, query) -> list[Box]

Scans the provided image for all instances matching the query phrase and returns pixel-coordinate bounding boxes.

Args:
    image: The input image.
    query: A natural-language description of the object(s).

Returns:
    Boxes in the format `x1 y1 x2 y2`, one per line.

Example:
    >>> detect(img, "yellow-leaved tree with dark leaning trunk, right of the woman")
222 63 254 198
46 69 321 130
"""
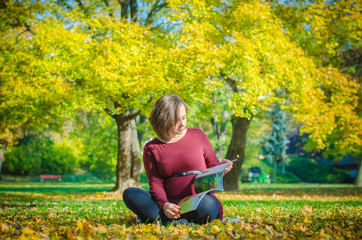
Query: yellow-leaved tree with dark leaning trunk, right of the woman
170 0 362 190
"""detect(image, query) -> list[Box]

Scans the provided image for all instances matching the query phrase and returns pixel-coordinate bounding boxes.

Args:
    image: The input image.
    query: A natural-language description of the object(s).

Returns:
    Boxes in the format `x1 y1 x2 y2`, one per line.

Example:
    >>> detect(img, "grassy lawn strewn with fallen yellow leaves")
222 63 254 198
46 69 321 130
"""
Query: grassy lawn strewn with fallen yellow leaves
0 182 362 239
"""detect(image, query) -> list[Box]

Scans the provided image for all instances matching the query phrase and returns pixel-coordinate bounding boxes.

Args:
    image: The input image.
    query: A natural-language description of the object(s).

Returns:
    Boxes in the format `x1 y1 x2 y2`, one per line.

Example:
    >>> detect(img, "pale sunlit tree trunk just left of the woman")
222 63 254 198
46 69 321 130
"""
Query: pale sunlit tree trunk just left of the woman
112 111 141 193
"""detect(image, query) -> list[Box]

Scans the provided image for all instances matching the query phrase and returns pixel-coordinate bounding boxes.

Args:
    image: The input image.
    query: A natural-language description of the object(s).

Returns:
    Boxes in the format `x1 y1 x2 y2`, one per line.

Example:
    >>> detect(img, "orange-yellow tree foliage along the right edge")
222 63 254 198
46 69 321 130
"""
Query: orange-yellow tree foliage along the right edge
269 0 362 186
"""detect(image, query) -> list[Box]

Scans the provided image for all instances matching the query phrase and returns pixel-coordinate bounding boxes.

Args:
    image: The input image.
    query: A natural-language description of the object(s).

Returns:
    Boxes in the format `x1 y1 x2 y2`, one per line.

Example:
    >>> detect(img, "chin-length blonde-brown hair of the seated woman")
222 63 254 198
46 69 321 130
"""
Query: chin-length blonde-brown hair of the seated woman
148 94 187 140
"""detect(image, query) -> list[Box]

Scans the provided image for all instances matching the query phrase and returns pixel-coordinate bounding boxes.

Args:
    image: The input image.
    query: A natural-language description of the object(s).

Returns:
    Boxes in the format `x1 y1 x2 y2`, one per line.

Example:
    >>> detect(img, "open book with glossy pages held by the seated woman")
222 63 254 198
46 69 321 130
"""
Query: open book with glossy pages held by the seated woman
178 159 237 214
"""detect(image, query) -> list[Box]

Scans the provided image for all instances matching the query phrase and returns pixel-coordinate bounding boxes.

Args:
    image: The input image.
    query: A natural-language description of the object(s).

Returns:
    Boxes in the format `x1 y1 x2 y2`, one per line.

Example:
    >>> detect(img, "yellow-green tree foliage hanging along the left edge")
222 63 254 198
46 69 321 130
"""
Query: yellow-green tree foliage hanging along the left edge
0 0 74 178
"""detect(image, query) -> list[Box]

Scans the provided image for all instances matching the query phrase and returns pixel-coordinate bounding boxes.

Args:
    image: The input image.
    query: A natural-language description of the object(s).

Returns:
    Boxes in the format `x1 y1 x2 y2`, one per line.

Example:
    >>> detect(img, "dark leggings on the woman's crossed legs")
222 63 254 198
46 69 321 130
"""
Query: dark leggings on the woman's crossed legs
123 188 219 225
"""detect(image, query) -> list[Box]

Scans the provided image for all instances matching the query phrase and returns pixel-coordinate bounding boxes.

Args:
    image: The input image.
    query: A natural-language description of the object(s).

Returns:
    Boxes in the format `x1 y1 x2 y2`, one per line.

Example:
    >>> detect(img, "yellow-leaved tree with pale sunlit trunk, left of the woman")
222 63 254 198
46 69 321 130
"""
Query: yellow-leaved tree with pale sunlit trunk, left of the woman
3 1 218 192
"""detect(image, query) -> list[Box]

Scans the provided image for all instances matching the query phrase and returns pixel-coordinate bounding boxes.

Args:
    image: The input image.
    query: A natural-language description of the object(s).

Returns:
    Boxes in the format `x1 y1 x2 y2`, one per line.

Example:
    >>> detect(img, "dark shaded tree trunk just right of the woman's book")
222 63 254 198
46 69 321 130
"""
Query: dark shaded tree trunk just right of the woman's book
224 116 251 191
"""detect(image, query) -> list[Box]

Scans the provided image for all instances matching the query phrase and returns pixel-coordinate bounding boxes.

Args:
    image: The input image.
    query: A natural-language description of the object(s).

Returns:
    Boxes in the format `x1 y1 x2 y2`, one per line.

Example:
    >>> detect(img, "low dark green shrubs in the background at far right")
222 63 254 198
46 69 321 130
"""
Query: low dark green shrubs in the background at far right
286 157 349 183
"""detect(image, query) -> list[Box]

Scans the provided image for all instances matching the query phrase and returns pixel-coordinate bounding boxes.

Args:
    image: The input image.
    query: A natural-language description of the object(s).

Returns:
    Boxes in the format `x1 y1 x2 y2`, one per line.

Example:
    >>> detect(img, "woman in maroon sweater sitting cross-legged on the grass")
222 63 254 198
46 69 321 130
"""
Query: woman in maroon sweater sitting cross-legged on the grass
123 94 232 225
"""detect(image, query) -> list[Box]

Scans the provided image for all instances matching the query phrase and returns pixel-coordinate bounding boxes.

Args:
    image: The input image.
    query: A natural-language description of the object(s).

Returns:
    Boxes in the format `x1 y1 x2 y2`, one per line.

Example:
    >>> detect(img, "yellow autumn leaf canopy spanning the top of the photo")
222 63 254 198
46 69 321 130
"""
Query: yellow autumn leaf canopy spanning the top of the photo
0 0 362 155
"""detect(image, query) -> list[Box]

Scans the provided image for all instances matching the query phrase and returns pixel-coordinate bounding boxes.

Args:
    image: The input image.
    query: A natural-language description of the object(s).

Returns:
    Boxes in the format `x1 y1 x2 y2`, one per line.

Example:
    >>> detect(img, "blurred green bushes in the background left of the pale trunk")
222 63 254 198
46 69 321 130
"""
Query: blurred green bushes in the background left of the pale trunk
4 112 126 180
